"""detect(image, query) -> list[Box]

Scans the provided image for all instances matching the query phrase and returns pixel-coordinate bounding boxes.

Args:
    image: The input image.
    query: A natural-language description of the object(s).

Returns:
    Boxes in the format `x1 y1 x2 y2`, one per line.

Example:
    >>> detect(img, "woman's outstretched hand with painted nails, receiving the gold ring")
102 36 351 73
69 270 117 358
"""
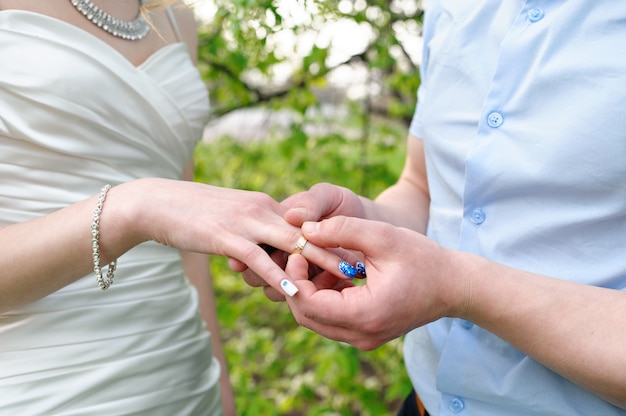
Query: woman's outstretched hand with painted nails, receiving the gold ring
109 179 342 293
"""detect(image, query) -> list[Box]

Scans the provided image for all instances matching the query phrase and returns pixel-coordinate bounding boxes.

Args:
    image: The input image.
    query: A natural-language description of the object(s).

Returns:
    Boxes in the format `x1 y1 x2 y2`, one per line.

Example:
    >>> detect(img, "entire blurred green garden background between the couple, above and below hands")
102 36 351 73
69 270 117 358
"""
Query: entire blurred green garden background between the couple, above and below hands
192 0 422 416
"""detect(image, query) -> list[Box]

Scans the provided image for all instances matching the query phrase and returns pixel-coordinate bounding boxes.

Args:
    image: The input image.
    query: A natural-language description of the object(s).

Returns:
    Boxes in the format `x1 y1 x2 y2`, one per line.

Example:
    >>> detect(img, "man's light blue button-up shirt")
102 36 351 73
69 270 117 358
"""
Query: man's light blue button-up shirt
405 0 626 416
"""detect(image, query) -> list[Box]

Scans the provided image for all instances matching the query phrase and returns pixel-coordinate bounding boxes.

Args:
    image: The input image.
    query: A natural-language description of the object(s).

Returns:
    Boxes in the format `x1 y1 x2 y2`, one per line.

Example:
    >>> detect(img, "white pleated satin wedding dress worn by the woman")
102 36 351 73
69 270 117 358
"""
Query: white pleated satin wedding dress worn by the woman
0 10 221 416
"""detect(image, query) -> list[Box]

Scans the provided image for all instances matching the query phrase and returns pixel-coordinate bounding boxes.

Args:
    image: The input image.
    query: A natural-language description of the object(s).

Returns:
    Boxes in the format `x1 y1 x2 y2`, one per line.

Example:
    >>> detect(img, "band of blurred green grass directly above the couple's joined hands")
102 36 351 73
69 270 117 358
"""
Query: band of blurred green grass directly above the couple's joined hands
196 113 406 200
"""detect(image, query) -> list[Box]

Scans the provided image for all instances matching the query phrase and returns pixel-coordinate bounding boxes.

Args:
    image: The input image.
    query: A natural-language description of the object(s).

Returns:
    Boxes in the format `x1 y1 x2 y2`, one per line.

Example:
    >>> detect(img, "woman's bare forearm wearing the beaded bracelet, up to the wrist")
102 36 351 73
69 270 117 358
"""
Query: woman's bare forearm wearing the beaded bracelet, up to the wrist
0 187 141 312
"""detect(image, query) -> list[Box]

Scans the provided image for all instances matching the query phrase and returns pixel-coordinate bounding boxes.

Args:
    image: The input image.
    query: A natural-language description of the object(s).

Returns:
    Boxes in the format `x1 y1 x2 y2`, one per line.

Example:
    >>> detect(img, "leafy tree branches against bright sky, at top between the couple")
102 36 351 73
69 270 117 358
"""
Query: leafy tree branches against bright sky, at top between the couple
192 0 422 121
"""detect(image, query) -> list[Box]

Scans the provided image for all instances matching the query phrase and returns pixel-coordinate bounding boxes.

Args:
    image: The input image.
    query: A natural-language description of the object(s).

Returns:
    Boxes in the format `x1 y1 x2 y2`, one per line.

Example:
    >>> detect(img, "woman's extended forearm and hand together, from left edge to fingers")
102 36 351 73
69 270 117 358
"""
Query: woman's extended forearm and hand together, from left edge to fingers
0 178 322 311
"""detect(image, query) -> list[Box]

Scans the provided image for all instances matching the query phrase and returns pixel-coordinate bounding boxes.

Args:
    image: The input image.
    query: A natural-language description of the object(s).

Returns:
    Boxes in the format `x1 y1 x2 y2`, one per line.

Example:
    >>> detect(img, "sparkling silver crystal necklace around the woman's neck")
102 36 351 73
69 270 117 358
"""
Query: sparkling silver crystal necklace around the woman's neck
70 0 150 40
